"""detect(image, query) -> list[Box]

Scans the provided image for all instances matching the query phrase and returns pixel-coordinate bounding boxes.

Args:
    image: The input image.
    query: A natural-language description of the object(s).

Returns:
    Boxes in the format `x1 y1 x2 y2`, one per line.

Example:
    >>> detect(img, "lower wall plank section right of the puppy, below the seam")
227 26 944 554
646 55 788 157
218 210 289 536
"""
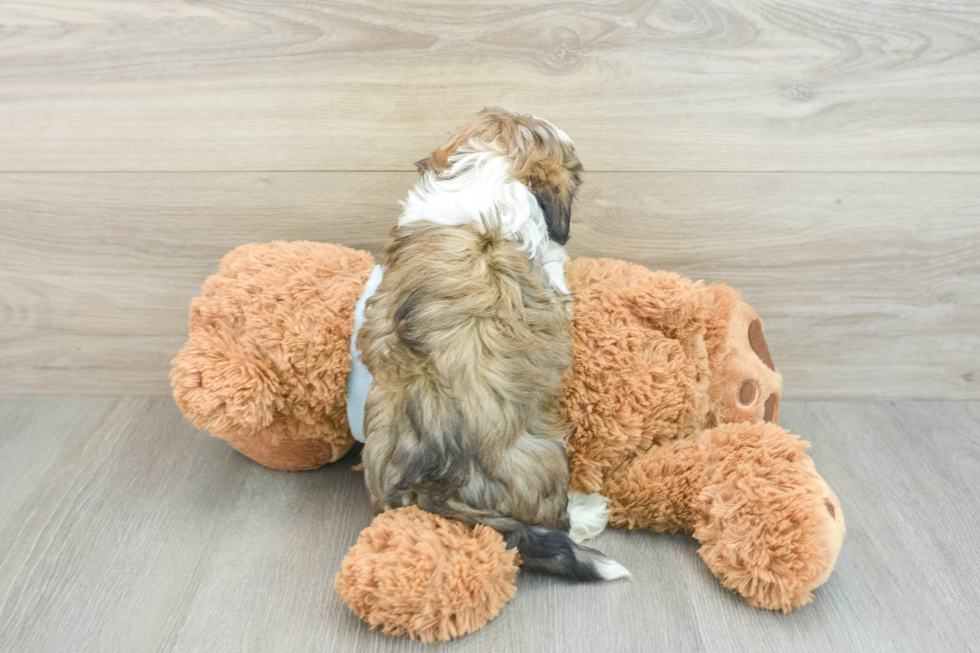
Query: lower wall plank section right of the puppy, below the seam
571 173 980 399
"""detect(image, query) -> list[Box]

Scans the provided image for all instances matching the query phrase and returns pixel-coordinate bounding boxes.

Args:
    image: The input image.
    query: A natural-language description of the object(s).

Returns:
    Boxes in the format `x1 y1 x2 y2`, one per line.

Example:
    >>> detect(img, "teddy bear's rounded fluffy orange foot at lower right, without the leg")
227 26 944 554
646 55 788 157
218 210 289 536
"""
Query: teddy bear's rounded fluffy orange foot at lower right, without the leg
694 424 845 612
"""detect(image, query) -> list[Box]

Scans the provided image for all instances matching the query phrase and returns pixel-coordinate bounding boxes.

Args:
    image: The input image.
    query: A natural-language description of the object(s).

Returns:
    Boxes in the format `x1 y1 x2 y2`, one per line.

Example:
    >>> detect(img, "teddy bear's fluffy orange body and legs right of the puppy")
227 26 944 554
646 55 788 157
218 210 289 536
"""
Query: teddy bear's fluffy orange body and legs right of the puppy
562 259 845 611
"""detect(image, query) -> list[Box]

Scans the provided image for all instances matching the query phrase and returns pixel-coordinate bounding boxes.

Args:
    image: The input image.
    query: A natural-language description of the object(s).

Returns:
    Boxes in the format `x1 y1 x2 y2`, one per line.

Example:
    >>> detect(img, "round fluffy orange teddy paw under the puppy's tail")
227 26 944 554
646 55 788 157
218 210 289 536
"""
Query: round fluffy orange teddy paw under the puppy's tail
334 506 520 642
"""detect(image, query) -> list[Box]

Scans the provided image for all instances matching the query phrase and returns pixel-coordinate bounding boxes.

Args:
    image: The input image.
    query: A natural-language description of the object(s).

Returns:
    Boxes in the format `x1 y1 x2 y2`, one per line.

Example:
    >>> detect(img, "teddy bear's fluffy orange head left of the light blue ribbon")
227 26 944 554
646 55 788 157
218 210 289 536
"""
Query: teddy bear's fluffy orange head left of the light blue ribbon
170 242 374 470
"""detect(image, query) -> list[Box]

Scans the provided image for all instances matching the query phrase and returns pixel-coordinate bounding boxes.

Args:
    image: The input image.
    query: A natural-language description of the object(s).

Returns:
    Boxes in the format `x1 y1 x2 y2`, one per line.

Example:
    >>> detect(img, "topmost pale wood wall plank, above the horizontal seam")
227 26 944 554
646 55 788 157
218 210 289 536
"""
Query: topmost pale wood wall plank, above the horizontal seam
0 0 980 172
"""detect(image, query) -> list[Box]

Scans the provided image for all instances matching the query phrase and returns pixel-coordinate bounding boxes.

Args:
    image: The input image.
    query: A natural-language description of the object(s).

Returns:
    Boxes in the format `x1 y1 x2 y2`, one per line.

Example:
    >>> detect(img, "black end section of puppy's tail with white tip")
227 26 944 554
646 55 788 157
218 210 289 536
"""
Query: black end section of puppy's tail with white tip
503 526 630 581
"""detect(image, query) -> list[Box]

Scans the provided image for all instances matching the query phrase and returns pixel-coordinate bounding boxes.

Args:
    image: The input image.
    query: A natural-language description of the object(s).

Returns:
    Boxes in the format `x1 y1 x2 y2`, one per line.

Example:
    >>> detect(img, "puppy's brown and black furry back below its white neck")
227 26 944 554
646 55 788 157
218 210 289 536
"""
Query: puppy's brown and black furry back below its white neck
358 222 571 526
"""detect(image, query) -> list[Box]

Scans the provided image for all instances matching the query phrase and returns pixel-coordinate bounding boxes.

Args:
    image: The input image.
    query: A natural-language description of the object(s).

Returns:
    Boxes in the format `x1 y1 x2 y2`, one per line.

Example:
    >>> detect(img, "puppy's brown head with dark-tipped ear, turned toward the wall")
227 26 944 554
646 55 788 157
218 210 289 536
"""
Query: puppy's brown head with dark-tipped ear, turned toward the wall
415 107 582 245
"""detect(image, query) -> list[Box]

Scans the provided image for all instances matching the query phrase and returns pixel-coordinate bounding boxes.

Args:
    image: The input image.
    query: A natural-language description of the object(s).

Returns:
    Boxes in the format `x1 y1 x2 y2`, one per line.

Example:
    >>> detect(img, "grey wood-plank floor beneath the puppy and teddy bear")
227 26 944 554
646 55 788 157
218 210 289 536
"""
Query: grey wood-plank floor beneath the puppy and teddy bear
0 397 980 653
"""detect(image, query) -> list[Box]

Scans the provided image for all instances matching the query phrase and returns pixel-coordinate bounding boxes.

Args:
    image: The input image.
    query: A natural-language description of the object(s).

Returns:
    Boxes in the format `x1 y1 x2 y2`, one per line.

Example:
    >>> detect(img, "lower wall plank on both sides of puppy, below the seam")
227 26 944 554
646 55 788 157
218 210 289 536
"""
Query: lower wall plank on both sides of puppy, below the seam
0 173 980 399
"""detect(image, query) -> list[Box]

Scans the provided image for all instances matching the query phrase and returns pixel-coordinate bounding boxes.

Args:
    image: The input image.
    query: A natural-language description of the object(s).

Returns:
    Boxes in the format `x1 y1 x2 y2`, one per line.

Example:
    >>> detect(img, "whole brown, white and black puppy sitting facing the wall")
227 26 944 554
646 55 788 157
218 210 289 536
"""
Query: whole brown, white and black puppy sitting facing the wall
357 109 629 580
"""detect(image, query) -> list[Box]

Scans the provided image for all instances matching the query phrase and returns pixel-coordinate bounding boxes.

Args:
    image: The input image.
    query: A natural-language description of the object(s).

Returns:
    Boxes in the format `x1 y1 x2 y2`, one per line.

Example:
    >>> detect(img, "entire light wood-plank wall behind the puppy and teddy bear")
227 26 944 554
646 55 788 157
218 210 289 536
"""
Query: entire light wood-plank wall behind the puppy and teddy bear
0 0 980 399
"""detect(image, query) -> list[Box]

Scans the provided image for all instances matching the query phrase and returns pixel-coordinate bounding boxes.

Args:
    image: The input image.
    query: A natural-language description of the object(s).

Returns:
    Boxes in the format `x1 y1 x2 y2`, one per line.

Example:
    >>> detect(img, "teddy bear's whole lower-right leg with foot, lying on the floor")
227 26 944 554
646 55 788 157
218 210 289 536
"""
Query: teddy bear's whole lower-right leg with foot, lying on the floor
604 423 845 612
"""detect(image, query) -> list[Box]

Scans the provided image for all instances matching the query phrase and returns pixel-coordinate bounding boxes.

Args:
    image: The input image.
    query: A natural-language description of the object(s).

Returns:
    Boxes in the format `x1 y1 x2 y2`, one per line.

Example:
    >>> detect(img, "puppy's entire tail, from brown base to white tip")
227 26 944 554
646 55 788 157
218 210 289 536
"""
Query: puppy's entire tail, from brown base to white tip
419 502 630 581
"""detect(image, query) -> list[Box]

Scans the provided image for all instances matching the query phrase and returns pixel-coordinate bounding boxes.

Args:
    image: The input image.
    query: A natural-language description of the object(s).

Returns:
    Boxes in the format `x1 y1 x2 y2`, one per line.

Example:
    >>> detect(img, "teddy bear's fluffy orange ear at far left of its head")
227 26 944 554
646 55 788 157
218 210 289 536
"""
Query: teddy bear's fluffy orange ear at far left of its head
170 329 282 439
